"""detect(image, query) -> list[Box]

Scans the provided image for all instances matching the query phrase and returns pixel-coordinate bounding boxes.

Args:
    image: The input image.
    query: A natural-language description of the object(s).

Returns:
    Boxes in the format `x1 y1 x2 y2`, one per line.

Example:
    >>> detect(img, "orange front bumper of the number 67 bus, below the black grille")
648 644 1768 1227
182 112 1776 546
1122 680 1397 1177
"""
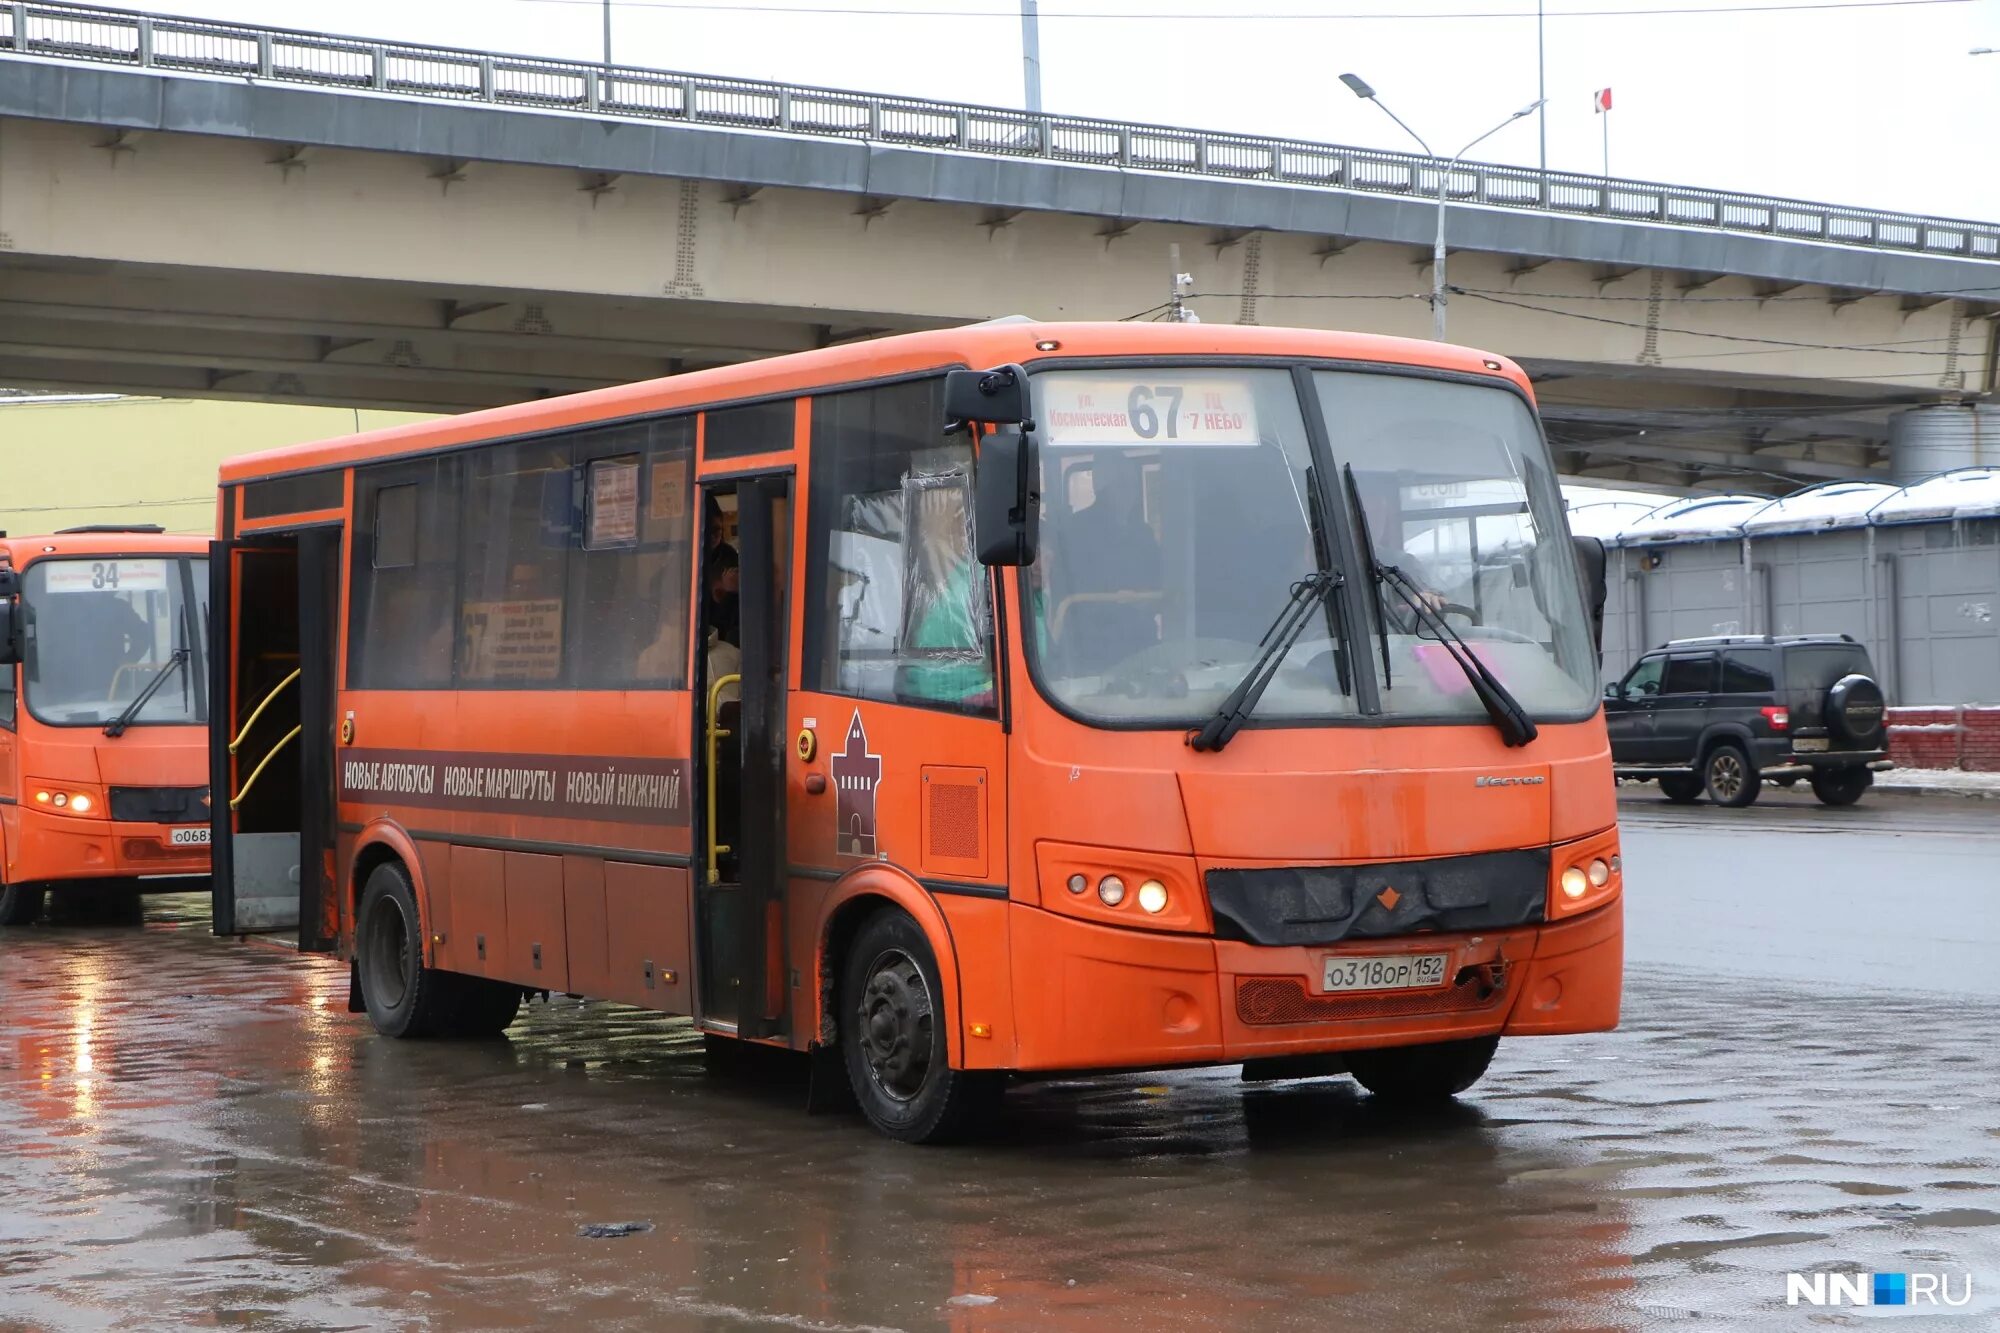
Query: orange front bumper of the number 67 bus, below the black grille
1010 897 1624 1069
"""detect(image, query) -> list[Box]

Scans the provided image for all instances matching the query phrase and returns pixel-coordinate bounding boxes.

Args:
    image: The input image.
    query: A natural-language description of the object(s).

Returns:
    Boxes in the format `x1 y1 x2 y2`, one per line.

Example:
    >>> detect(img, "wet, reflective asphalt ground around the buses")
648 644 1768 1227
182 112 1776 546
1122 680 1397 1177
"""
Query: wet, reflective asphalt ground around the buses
0 793 2000 1331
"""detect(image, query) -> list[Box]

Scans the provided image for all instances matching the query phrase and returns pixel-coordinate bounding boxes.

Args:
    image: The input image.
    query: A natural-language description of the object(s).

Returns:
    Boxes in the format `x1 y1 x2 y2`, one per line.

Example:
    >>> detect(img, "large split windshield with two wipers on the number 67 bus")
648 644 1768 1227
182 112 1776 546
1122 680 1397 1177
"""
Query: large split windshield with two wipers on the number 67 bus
1028 368 1596 727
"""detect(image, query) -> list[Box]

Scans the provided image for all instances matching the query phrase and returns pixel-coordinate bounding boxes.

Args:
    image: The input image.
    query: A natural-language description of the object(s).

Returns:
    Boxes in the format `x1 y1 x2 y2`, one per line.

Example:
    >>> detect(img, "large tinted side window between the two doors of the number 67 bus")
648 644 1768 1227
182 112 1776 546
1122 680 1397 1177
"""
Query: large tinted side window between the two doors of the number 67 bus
348 418 694 689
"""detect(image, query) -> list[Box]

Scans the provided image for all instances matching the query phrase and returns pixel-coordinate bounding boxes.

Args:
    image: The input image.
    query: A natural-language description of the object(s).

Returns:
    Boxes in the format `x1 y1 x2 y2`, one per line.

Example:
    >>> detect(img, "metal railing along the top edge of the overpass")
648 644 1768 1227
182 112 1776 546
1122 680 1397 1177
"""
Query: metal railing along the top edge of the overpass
0 0 2000 260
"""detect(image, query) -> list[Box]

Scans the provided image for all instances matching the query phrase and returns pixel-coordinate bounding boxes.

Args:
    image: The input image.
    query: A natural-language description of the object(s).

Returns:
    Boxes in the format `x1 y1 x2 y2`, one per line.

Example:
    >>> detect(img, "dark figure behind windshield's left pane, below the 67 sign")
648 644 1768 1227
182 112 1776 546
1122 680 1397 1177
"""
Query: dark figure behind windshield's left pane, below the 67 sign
1056 452 1162 675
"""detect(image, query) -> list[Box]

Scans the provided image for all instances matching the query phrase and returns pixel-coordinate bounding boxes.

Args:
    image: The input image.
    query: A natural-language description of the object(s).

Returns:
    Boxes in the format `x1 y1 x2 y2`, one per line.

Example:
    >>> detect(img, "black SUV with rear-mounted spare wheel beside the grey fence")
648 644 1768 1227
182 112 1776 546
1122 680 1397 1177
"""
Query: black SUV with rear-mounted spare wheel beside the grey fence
1604 634 1892 805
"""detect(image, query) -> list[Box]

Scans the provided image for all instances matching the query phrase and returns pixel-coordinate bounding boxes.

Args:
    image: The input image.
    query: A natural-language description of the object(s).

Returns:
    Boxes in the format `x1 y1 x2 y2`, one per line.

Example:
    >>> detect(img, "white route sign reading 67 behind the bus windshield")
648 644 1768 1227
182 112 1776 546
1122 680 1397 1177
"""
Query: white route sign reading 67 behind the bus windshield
1036 374 1258 446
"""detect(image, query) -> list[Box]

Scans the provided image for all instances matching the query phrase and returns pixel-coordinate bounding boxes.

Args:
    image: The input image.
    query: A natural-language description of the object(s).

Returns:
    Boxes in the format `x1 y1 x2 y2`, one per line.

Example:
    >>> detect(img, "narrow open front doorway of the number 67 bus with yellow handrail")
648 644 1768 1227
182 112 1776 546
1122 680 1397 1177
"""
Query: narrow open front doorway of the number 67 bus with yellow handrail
694 474 792 1037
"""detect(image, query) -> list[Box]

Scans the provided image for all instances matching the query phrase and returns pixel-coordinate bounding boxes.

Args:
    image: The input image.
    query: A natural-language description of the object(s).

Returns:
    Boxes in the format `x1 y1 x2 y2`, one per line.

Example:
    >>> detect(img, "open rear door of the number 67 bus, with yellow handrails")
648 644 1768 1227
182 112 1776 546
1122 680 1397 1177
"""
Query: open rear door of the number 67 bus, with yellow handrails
208 526 340 951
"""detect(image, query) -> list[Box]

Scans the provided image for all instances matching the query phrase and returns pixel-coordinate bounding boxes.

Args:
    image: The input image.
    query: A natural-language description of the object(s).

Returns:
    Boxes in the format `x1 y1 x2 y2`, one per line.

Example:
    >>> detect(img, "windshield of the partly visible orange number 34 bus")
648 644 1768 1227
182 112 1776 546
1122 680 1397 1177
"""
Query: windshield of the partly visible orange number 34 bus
22 556 208 727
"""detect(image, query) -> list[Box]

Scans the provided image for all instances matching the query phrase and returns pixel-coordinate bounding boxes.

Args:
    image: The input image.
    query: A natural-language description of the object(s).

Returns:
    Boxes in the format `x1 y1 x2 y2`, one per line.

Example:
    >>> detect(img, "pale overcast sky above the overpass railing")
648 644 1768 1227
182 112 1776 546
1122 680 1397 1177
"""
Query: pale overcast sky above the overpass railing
126 0 2000 220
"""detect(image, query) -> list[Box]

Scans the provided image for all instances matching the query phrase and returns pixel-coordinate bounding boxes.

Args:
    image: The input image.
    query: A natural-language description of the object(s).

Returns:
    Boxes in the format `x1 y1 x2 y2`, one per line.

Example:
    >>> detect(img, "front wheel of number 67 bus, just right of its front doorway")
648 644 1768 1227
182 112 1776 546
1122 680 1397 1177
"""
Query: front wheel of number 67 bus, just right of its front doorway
840 909 1000 1143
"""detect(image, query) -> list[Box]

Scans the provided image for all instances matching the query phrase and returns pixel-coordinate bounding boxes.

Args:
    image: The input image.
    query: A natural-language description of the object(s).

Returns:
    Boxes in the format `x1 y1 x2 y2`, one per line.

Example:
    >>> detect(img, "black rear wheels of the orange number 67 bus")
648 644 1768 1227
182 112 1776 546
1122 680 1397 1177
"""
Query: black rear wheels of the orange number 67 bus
354 861 520 1037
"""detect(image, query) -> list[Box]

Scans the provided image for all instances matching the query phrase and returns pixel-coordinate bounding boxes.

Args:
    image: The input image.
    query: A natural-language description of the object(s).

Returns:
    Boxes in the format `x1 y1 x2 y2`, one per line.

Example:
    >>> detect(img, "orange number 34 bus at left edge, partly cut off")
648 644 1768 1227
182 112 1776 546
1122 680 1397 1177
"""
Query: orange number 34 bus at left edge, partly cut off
0 526 210 925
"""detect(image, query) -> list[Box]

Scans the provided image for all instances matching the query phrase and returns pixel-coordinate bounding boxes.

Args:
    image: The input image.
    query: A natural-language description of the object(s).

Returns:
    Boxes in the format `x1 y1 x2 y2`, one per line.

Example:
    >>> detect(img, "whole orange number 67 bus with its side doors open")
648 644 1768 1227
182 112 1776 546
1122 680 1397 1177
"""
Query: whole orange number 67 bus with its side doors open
212 320 1622 1141
